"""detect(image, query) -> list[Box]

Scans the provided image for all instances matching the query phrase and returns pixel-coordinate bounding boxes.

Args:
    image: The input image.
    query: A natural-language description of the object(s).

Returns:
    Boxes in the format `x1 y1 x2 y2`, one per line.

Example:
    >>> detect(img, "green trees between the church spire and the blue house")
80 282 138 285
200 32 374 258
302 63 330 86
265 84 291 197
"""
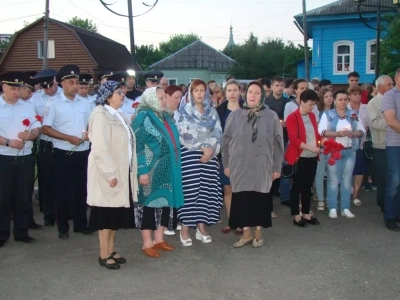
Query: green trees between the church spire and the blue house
223 33 304 79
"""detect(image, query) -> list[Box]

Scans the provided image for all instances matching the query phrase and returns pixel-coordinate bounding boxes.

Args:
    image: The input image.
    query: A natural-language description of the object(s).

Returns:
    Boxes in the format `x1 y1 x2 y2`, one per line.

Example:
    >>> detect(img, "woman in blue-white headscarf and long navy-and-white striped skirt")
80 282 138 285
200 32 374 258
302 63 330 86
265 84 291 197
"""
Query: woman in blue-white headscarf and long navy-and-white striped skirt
177 79 222 246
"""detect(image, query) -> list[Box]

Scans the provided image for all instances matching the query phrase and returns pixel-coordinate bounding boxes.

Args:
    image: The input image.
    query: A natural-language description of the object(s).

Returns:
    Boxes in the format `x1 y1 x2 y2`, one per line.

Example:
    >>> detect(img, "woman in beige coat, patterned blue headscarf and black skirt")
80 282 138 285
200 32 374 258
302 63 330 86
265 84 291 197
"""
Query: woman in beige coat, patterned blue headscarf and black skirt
87 81 138 269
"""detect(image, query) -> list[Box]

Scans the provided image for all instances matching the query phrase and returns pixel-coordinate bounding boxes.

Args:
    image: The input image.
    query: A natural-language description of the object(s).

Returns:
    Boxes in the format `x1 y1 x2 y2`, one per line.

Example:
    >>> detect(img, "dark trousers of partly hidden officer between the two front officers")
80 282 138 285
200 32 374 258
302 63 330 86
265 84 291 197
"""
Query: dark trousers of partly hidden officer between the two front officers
38 140 56 222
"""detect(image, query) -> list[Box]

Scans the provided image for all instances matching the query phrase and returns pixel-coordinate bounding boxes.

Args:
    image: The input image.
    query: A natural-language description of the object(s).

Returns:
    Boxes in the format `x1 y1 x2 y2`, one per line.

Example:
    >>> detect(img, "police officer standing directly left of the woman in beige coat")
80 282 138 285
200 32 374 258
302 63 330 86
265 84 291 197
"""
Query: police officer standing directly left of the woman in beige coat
42 65 91 240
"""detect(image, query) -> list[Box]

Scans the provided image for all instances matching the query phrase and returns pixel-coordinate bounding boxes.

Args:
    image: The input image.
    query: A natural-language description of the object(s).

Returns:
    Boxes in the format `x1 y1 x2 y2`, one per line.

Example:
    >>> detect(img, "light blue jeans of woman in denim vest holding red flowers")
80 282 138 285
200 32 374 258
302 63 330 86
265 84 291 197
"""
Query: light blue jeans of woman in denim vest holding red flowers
327 149 356 210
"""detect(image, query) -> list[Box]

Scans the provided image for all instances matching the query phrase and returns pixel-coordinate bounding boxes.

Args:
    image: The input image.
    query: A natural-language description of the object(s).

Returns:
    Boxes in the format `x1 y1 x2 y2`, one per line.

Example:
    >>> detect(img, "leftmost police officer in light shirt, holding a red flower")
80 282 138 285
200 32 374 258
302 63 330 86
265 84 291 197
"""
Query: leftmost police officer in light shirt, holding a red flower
0 72 40 247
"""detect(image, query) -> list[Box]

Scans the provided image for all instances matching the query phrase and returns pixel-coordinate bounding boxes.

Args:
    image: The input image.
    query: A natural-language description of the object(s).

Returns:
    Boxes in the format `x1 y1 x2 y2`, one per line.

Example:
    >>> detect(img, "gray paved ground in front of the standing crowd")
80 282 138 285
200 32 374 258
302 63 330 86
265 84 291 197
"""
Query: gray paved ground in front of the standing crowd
0 192 400 300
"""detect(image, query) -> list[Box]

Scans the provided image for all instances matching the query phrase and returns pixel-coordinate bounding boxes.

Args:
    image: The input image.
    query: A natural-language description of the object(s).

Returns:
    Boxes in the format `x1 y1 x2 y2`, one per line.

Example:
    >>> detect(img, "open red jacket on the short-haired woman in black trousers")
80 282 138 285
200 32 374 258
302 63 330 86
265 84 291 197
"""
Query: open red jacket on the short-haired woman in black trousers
285 109 321 165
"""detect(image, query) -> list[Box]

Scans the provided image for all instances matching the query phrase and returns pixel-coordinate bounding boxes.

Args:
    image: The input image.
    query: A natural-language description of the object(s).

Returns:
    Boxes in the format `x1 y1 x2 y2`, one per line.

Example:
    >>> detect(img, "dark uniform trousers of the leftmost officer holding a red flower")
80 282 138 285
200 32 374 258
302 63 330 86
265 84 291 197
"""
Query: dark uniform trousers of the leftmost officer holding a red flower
0 154 33 241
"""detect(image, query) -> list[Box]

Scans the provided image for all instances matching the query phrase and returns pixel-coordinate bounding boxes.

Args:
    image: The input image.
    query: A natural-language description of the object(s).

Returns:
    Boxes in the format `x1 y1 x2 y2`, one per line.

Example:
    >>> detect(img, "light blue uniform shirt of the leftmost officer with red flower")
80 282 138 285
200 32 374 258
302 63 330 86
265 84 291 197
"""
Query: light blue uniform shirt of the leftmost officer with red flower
0 96 40 156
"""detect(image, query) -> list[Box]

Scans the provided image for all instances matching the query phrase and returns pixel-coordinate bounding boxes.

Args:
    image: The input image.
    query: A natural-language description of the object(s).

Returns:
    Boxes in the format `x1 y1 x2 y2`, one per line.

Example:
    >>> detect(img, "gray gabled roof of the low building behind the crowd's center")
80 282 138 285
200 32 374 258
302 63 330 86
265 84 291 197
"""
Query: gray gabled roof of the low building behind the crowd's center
149 40 236 71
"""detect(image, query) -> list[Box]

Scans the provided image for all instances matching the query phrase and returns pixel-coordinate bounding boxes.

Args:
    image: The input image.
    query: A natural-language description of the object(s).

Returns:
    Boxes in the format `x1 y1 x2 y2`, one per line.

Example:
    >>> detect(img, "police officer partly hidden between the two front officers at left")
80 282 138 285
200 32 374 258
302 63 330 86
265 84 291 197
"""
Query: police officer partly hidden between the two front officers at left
31 69 62 226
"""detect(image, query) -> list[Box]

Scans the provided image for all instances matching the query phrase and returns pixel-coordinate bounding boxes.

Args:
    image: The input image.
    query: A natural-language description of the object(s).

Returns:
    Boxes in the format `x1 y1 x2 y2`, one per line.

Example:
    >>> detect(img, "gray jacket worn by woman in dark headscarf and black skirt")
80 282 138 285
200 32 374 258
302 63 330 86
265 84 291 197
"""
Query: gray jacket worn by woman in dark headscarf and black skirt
222 108 284 193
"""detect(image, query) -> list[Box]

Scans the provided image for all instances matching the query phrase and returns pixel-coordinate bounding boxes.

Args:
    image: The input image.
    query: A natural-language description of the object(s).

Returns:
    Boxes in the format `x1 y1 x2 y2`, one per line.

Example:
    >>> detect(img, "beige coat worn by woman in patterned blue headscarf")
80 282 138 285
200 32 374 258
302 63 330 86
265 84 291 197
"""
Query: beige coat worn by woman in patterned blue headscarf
87 105 138 207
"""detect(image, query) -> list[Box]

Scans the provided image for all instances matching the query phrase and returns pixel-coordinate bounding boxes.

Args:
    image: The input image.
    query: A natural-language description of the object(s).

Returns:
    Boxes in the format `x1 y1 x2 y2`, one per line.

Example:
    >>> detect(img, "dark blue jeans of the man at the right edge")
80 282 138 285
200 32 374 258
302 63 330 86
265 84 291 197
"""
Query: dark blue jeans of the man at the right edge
383 147 400 221
